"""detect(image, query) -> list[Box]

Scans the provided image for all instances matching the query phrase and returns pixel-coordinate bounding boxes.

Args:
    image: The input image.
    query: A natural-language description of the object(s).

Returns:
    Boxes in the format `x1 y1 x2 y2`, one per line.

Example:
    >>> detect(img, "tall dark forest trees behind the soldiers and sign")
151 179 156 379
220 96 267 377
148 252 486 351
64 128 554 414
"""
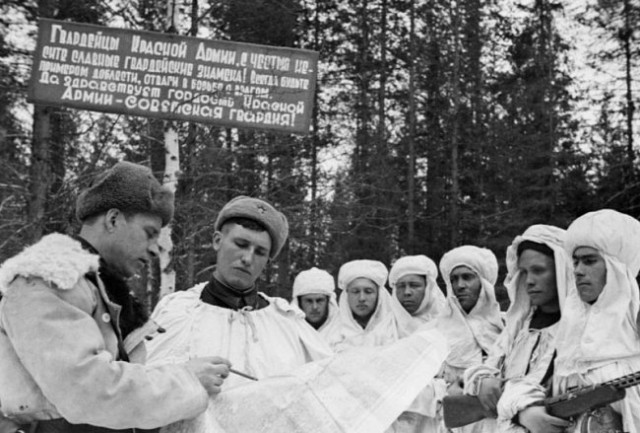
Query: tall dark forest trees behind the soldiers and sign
0 0 640 305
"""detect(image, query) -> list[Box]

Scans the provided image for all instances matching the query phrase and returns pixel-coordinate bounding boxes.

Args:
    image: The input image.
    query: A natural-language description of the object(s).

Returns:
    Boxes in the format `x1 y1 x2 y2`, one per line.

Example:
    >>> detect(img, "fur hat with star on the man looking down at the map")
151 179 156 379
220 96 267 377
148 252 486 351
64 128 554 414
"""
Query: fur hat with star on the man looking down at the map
214 195 289 259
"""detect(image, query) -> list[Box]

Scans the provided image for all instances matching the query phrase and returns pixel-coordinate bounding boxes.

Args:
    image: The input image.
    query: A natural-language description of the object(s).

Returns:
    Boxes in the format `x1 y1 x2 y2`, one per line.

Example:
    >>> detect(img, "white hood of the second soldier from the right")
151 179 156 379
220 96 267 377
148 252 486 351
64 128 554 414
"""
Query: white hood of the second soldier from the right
504 224 574 342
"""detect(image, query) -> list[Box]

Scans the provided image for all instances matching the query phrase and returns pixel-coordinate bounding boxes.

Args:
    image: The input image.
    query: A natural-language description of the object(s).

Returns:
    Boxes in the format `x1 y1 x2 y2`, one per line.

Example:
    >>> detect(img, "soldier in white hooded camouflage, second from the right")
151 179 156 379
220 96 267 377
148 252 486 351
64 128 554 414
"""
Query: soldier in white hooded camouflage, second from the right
464 225 573 432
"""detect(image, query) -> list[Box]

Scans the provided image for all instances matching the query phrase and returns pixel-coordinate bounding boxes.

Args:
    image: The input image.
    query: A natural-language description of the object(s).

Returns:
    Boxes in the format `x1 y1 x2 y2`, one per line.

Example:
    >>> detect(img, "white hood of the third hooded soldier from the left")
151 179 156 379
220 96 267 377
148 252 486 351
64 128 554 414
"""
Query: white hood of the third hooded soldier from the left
389 255 446 326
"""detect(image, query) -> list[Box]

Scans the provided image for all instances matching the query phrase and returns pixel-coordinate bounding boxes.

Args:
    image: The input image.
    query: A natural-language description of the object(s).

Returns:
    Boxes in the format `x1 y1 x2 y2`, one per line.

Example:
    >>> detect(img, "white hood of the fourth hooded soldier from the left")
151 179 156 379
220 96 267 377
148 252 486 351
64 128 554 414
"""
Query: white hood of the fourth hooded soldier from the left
438 245 504 367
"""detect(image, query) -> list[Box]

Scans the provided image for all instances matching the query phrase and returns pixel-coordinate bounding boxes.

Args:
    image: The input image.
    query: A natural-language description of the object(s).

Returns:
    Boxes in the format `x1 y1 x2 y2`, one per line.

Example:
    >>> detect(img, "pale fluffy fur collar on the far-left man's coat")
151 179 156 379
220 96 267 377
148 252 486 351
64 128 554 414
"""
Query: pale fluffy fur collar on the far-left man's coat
0 233 100 293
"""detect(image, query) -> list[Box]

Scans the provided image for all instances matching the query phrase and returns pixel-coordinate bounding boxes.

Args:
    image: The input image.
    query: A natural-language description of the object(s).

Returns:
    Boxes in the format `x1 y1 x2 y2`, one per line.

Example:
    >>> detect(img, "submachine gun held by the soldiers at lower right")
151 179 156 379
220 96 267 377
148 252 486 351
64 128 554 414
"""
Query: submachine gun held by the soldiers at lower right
442 371 640 433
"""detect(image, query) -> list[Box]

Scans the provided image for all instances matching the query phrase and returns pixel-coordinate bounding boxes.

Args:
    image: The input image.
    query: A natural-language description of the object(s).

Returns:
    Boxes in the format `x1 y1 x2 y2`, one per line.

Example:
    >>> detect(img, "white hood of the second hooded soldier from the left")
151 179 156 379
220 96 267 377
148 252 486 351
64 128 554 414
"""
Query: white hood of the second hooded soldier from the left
338 260 409 346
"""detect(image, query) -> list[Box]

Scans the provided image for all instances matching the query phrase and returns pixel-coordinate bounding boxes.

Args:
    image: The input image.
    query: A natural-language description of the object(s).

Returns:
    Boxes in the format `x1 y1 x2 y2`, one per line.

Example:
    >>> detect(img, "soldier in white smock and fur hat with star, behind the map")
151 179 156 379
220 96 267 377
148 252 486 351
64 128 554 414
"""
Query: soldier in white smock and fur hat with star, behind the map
149 196 332 432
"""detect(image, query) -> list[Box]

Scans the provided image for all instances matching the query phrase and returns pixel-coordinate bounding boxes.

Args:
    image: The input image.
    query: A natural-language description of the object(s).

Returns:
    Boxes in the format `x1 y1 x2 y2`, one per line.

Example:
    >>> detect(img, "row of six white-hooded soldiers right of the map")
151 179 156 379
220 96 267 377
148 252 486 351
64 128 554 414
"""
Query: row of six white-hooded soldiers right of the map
292 219 640 433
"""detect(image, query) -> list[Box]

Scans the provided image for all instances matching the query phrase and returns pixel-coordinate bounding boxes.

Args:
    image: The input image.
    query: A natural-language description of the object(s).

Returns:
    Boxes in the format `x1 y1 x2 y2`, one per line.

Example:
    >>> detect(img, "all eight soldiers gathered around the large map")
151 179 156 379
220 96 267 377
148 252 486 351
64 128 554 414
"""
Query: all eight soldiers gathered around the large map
0 162 640 433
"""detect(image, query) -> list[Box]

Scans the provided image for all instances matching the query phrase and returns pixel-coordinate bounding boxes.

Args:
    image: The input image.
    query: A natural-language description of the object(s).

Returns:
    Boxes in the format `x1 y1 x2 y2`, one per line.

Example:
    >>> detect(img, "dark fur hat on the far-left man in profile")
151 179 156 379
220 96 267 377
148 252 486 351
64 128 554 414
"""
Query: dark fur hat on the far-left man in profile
76 161 173 226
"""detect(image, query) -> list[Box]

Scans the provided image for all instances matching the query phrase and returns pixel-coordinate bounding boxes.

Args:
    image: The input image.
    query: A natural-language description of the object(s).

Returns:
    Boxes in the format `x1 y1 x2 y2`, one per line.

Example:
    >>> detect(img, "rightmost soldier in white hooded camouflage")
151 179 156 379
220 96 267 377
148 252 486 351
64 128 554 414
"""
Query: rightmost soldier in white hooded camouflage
519 209 640 433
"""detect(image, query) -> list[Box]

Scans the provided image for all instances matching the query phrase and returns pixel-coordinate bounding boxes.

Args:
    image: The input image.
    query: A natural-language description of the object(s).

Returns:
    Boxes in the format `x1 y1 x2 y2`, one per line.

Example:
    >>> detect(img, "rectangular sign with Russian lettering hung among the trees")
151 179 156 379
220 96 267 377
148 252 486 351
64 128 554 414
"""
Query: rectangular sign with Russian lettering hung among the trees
29 19 318 134
